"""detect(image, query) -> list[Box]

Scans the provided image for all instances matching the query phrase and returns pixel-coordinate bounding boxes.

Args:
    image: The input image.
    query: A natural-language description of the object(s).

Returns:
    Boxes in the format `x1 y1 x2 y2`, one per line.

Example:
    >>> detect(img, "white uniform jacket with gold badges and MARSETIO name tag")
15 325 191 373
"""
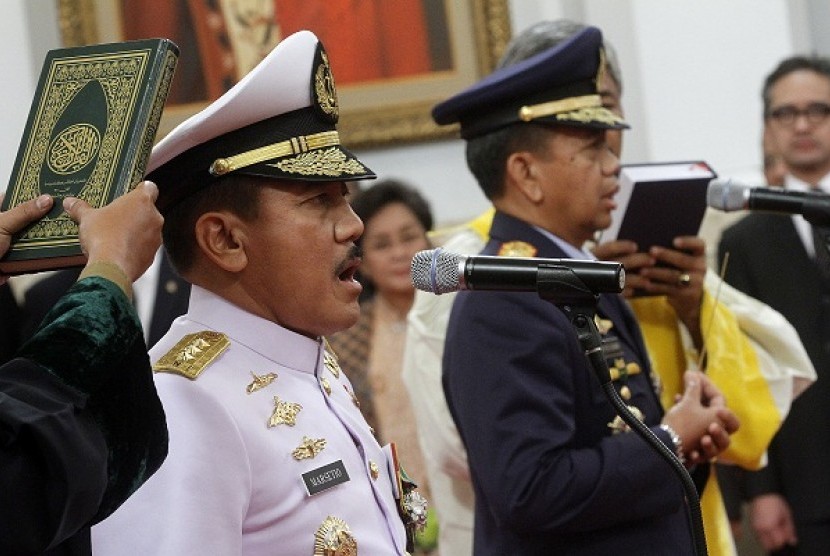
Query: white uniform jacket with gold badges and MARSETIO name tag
93 286 406 556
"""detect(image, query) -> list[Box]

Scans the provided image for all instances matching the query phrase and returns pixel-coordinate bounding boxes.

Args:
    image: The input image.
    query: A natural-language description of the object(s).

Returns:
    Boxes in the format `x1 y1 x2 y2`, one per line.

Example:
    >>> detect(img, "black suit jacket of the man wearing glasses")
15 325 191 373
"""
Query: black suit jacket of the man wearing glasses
719 213 830 523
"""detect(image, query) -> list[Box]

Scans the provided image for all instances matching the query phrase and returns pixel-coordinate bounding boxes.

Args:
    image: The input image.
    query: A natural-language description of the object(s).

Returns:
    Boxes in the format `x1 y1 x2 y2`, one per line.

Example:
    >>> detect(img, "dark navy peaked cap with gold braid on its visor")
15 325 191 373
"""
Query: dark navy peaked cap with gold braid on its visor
432 27 629 139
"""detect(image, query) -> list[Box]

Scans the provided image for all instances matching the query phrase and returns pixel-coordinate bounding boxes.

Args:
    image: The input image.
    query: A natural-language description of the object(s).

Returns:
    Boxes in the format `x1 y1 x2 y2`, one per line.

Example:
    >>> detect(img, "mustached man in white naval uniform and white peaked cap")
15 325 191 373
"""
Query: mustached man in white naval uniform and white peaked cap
93 31 424 556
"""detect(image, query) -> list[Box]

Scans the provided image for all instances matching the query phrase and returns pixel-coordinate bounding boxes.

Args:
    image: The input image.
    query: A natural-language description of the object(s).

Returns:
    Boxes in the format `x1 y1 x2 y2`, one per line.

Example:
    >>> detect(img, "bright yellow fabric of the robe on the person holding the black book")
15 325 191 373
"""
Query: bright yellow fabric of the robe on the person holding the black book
631 293 781 555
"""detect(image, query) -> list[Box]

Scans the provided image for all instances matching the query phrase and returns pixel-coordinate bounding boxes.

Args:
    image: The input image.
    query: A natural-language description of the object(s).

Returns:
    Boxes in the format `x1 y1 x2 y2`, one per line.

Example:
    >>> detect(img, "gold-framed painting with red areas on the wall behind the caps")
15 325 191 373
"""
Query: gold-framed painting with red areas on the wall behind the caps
58 0 510 148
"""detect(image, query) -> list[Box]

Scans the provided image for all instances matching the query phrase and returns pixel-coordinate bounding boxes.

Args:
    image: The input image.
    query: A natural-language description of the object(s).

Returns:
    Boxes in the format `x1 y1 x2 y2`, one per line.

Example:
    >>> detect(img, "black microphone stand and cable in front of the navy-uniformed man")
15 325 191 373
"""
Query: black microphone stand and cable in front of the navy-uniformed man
536 265 707 556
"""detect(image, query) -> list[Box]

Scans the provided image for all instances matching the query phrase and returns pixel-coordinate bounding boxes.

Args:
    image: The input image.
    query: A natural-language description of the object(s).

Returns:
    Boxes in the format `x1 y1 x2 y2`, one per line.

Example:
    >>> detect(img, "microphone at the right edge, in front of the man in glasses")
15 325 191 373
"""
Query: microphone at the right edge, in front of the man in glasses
706 178 830 226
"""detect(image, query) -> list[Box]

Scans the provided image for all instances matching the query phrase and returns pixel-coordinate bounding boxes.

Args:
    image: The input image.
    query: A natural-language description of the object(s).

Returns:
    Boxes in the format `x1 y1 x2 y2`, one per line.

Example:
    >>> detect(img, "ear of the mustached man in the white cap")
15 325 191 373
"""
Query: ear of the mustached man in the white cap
194 211 248 272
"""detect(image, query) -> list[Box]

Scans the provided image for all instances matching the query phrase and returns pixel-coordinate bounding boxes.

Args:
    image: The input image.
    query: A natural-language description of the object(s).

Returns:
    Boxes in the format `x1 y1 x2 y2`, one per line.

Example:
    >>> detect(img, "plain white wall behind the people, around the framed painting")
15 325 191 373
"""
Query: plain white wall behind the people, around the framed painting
0 0 827 223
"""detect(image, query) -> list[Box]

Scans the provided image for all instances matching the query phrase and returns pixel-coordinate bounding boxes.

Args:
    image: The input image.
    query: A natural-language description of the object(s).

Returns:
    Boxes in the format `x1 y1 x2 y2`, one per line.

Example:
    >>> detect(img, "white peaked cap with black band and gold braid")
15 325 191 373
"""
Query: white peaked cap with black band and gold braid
147 31 375 210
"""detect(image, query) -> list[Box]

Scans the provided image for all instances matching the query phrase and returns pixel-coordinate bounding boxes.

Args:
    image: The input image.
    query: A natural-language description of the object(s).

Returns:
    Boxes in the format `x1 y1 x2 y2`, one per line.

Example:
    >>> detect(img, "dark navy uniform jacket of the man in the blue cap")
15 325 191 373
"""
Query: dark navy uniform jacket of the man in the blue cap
443 213 694 556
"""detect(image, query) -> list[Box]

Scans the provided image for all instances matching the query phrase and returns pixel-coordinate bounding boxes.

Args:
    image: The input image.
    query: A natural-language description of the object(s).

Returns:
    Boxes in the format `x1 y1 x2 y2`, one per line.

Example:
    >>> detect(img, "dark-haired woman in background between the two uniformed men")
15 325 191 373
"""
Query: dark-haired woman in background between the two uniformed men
328 180 434 554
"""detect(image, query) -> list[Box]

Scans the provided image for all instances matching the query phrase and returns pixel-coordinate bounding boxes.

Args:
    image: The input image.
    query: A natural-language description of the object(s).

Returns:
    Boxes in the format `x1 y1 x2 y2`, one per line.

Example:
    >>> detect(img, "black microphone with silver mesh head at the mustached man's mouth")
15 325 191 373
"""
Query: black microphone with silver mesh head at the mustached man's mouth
412 248 625 300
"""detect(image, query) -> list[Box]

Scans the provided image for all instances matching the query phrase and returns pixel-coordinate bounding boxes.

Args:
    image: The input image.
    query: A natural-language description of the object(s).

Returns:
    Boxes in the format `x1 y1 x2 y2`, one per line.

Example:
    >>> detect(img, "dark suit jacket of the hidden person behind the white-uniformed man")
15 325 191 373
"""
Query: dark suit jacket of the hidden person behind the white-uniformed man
21 251 190 347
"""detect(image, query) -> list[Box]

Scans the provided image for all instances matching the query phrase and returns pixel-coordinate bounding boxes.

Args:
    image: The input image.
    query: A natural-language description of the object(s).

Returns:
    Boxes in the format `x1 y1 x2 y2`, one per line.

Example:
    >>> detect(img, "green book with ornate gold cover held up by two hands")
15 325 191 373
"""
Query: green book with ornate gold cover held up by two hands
0 39 179 274
